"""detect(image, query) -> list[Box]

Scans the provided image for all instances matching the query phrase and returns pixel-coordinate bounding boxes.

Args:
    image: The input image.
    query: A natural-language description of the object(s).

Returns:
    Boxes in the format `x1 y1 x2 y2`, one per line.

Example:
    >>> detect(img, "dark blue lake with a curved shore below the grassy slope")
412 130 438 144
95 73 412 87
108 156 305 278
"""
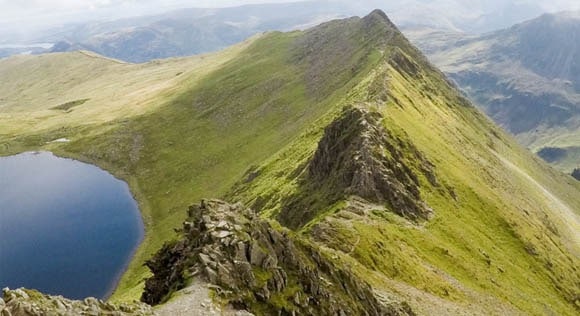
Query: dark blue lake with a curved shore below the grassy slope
0 152 143 299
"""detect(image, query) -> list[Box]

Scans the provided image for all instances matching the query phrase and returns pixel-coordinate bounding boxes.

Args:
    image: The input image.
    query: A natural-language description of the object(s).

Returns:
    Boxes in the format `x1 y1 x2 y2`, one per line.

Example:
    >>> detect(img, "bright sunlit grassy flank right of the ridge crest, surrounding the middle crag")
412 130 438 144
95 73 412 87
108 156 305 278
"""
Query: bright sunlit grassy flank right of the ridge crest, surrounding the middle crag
230 21 580 315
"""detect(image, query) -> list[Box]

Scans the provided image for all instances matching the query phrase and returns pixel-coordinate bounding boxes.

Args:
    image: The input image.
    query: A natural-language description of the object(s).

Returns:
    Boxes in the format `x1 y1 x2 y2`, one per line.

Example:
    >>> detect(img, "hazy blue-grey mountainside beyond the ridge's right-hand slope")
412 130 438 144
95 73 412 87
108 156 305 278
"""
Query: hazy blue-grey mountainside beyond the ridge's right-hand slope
408 12 580 172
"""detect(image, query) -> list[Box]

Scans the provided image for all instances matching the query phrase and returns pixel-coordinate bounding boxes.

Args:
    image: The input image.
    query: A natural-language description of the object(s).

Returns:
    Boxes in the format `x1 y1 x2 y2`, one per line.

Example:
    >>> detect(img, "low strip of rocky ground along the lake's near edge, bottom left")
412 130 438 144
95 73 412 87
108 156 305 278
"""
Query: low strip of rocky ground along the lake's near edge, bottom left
0 289 154 316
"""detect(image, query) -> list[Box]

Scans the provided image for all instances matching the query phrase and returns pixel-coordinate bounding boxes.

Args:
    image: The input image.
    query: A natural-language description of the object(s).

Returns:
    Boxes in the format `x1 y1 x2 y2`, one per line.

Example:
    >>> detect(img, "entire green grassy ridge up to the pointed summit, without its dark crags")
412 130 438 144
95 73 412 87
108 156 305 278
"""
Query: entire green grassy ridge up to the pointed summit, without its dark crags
0 9 580 315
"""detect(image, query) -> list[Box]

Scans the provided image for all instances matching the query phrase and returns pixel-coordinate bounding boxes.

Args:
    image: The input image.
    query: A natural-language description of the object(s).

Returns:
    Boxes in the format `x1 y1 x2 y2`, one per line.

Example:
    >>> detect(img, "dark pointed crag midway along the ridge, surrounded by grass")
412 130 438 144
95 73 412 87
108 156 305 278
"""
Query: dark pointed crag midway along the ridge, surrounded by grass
278 106 437 228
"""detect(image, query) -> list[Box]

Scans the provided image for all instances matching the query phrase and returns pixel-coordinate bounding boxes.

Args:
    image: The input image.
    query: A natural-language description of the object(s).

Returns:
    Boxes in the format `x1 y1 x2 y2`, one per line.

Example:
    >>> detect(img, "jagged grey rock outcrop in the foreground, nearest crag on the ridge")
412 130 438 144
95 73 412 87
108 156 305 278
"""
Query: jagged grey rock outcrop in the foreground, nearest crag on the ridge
142 200 413 315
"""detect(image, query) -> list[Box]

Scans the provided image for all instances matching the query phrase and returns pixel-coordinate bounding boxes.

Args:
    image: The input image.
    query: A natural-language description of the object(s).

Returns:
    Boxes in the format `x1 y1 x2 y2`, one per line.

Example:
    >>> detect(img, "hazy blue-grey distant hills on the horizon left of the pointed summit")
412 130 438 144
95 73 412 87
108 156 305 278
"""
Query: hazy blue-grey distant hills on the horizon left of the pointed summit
51 2 349 62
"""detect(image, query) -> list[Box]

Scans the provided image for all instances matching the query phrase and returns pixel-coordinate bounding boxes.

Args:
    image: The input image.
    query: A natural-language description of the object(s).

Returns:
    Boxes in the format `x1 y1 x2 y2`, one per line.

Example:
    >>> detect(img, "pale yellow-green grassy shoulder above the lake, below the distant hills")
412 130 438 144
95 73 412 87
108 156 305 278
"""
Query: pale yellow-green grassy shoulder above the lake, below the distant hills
0 40 252 148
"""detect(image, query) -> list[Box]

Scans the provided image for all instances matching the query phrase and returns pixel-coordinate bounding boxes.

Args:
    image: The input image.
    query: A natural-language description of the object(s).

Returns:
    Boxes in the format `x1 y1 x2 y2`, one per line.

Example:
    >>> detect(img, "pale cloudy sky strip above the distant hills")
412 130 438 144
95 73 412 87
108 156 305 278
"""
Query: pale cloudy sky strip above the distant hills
0 0 580 43
